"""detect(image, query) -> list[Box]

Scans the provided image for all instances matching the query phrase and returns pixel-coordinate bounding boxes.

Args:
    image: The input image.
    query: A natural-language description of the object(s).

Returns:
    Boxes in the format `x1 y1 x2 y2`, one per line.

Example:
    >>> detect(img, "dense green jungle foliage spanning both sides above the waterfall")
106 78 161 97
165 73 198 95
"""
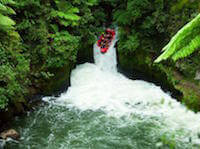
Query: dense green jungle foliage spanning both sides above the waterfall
0 0 200 112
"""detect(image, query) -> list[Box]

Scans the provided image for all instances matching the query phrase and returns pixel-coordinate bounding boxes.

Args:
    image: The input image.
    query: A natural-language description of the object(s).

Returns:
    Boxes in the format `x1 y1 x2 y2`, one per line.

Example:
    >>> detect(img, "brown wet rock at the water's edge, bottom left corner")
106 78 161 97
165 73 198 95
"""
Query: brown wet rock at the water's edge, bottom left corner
0 129 20 140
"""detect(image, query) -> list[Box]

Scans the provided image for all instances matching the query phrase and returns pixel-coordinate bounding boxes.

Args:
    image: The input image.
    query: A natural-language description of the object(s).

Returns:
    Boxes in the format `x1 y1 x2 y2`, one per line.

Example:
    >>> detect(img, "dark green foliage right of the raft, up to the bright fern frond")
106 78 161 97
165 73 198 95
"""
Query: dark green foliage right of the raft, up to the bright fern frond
112 0 200 55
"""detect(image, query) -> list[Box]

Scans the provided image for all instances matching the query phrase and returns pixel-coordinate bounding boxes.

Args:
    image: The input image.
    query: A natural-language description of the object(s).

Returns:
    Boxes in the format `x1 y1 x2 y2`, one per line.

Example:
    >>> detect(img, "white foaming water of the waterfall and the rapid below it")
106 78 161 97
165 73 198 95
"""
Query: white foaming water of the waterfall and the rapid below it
44 33 200 147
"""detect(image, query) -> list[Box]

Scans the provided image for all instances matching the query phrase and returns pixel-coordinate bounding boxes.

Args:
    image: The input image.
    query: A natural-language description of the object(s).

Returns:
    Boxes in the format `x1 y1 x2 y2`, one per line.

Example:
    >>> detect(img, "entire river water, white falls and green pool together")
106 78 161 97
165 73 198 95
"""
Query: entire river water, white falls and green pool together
5 34 200 149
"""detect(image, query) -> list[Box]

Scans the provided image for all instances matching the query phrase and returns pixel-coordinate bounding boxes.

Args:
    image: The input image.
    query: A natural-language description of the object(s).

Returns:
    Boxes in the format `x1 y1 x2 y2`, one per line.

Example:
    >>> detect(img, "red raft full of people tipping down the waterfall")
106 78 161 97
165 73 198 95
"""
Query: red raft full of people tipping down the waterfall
97 29 115 53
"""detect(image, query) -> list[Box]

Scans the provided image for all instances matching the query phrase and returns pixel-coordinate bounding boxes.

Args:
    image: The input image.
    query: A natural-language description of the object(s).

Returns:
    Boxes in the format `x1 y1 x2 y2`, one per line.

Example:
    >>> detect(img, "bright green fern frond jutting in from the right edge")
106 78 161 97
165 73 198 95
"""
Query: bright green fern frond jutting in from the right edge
155 14 200 63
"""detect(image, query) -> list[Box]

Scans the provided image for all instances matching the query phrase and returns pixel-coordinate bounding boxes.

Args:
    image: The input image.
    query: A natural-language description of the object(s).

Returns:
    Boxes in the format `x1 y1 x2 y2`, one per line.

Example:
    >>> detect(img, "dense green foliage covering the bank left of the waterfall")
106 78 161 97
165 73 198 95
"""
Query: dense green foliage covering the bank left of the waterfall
0 0 105 109
